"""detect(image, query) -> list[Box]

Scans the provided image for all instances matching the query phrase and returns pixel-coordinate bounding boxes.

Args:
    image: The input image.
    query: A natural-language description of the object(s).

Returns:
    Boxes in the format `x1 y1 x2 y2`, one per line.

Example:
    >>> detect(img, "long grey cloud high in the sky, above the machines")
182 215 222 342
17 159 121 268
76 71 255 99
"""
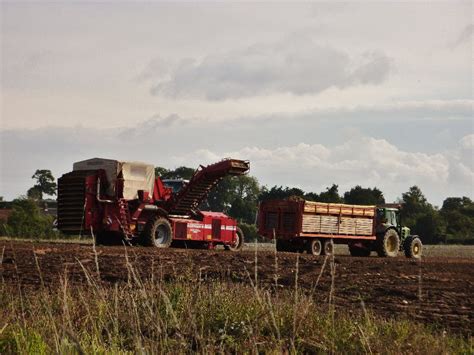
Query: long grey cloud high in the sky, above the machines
146 36 392 100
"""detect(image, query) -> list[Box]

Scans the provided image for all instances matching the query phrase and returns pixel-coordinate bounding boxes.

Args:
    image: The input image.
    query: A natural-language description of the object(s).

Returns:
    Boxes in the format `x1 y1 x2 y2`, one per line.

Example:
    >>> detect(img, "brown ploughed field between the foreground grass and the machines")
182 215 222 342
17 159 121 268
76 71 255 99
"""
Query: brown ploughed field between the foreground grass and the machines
0 240 474 336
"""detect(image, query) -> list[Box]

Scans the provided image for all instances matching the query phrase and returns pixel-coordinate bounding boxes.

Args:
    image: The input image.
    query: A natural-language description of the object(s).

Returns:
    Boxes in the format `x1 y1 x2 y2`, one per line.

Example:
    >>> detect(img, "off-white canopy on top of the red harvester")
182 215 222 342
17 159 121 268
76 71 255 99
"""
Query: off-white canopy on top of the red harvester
73 158 155 200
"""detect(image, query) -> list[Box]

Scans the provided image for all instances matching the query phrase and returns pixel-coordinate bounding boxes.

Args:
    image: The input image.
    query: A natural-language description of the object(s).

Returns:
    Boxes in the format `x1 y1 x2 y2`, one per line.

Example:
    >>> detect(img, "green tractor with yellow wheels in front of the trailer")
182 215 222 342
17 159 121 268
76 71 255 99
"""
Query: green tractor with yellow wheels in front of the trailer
373 205 422 259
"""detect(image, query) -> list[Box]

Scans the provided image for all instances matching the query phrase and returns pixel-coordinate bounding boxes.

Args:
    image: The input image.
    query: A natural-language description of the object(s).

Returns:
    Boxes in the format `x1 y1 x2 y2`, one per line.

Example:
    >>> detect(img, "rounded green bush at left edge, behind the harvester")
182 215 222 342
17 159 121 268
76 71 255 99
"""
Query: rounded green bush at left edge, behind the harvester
0 198 59 239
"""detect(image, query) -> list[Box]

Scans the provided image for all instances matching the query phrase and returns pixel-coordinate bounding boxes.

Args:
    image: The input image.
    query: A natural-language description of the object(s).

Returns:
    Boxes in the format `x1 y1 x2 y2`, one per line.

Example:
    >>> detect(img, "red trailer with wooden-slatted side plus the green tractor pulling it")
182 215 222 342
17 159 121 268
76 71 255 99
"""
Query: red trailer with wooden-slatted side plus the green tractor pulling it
258 199 422 258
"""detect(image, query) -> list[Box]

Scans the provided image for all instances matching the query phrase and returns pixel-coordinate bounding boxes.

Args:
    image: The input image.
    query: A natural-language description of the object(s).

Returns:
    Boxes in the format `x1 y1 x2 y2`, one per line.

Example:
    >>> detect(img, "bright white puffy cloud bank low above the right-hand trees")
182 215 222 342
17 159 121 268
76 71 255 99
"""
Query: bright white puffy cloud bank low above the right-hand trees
173 135 474 203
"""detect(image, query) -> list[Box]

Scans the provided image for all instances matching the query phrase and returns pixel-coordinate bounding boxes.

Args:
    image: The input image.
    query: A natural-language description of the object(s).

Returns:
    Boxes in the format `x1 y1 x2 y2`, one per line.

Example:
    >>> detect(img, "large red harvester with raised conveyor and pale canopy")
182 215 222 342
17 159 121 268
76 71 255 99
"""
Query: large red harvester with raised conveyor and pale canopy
58 158 250 250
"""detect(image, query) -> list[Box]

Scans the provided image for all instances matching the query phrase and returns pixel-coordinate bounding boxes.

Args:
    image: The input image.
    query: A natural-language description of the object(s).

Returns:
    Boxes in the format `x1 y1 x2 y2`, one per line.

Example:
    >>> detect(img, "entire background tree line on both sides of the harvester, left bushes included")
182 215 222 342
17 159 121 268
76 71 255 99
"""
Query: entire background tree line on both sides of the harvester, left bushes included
1 166 474 244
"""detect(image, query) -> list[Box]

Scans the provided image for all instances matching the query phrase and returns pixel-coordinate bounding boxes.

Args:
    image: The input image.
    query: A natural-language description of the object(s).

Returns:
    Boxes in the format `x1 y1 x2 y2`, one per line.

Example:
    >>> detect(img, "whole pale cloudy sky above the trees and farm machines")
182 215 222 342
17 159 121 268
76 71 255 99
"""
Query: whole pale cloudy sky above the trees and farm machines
0 1 474 206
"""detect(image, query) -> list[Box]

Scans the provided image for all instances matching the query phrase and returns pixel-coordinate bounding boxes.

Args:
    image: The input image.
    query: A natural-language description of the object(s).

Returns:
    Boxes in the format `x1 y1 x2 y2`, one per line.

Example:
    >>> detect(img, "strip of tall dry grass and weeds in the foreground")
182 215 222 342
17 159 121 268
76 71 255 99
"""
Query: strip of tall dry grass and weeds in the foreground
0 280 472 354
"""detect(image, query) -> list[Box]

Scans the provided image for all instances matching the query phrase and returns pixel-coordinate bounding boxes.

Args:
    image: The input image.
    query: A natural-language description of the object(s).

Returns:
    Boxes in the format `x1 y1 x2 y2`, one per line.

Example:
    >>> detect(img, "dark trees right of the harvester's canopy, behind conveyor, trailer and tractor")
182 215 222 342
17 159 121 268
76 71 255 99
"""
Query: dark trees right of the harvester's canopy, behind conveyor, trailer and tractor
156 167 474 244
